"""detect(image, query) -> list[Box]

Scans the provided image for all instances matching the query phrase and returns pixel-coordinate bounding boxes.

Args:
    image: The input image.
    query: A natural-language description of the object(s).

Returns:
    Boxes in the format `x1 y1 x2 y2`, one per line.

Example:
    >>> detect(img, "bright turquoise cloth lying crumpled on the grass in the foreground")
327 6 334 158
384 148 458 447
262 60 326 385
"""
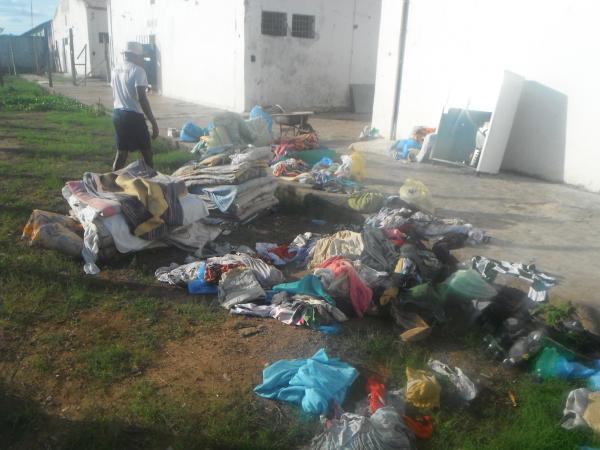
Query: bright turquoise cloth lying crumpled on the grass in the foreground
254 348 358 414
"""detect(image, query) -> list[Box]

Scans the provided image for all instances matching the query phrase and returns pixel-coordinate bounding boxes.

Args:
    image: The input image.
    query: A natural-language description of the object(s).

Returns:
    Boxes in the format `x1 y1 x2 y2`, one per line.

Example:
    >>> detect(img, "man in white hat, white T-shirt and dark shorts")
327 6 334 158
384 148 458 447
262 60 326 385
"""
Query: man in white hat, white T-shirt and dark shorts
111 42 158 171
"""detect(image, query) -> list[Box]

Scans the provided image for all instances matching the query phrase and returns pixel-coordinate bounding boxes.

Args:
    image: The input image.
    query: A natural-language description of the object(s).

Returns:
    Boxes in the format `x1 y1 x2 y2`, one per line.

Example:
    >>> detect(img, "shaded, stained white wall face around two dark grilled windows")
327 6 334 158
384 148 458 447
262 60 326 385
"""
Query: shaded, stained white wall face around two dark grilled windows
245 0 381 110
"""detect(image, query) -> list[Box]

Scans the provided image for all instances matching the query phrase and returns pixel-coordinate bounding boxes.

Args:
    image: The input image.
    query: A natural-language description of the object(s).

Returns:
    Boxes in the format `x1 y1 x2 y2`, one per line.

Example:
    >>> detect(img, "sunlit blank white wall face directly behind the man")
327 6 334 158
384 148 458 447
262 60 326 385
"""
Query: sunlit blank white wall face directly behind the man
109 0 244 111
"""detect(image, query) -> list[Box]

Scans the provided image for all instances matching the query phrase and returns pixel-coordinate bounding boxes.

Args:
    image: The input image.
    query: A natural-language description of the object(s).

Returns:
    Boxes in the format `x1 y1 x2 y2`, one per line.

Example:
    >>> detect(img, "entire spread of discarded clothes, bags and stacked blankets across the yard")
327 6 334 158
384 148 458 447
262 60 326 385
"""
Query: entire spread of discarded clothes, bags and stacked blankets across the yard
23 116 600 449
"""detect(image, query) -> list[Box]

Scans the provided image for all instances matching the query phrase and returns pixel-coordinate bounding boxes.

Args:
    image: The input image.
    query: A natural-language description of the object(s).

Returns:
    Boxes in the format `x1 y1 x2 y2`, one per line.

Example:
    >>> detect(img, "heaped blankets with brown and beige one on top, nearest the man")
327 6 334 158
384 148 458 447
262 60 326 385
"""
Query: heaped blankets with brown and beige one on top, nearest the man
23 160 221 274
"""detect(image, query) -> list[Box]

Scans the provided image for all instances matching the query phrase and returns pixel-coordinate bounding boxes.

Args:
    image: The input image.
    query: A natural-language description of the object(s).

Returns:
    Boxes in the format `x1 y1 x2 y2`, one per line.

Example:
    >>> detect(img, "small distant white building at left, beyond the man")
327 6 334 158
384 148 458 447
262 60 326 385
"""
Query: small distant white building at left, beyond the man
52 0 110 78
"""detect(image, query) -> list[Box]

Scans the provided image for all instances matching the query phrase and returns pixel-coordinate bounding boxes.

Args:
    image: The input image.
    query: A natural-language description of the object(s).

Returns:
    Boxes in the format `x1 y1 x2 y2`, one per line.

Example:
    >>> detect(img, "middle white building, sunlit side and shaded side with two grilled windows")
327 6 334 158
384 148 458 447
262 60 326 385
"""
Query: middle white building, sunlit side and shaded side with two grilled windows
108 0 381 111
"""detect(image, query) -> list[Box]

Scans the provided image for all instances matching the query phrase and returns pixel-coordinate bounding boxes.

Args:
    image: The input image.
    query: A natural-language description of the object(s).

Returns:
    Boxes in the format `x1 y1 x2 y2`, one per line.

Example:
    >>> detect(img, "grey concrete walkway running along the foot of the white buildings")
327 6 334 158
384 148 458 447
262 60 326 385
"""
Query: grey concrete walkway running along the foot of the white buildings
25 77 600 334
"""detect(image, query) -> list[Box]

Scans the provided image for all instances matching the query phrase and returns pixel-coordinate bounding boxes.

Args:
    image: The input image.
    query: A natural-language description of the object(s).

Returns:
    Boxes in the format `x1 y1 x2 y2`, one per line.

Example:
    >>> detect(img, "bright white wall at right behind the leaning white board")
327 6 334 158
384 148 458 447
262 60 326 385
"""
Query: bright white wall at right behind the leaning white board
373 0 600 191
